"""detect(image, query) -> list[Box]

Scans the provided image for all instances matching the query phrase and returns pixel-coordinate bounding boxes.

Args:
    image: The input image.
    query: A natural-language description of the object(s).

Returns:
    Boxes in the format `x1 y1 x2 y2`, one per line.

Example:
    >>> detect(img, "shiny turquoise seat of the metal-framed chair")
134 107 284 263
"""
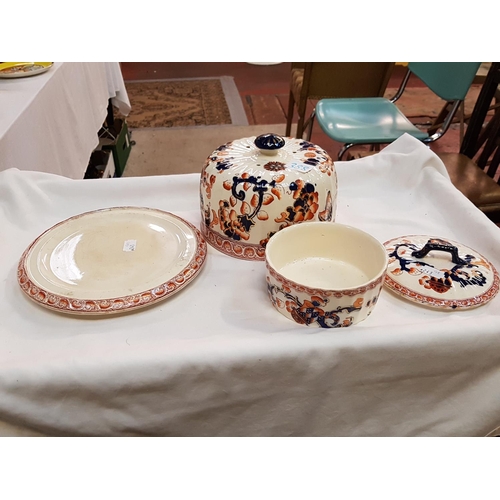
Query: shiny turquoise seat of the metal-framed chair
316 97 429 144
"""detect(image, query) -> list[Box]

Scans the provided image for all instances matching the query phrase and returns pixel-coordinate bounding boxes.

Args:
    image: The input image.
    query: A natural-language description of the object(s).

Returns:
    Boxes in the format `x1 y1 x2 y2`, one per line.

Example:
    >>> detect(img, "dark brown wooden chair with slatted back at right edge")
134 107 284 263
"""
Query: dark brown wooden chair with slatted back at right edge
438 63 500 223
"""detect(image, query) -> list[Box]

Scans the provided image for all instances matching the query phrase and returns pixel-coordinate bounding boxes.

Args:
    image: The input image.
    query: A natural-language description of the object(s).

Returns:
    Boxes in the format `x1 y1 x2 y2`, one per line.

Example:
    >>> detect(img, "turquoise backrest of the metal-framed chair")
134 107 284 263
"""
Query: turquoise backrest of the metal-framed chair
408 62 481 101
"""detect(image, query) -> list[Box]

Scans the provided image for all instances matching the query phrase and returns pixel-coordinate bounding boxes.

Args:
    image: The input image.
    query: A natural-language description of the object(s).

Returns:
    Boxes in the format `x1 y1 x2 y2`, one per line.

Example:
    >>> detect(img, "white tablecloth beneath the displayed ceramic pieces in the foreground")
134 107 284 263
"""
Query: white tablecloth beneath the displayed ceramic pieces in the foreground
0 136 500 436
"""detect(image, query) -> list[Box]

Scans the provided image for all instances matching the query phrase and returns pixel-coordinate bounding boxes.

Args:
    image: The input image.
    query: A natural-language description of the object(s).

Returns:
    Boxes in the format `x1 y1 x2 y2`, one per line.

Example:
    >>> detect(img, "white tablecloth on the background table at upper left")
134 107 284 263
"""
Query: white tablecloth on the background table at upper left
0 62 130 179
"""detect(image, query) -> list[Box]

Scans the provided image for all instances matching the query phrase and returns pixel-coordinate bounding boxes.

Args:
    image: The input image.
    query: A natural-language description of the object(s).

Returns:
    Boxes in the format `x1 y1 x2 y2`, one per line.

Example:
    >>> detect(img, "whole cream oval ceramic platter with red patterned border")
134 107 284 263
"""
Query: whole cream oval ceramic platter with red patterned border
18 207 207 315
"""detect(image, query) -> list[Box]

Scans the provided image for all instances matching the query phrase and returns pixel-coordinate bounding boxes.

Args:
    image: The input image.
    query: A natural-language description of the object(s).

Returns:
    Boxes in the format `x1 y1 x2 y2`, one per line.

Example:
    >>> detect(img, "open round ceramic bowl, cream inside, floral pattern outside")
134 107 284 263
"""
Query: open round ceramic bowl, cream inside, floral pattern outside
266 222 388 328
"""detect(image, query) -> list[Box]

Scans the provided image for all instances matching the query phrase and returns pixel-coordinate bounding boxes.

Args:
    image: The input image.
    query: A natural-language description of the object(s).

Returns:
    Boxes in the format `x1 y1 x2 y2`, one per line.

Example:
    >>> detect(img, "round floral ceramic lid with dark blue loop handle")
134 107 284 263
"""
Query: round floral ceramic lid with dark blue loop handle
384 235 500 310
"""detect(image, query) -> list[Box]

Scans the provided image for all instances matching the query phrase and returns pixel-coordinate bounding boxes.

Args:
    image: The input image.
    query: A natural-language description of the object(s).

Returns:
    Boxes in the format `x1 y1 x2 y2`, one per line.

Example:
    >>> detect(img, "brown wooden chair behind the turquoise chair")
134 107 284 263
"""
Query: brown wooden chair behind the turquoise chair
285 62 395 139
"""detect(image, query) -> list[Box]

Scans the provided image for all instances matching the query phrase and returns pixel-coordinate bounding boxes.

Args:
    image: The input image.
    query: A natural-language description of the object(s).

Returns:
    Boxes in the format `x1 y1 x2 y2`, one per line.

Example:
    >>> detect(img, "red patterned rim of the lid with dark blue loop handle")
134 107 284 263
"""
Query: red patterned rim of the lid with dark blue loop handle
384 235 500 311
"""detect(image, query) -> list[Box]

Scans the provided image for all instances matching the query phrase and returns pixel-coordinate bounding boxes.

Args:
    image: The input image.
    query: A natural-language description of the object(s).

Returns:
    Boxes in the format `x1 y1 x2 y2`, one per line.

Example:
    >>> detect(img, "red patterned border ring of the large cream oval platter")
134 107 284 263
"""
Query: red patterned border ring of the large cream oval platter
17 207 207 315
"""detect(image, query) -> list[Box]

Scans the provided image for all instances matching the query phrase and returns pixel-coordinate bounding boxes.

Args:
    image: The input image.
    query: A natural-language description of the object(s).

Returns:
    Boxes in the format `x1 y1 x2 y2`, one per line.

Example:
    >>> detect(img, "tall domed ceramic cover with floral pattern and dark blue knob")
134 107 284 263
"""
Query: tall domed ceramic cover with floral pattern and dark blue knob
200 134 337 260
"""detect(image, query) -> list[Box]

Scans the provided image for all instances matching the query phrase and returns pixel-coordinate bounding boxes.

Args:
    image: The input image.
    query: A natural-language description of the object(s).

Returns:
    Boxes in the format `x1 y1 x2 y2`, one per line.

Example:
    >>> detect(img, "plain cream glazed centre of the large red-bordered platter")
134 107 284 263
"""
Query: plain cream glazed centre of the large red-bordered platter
26 208 197 300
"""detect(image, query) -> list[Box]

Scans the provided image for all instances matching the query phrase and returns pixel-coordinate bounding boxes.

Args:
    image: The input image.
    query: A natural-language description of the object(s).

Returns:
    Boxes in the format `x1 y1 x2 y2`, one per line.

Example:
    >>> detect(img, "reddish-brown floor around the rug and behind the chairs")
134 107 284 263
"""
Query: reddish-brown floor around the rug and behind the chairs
121 62 474 158
